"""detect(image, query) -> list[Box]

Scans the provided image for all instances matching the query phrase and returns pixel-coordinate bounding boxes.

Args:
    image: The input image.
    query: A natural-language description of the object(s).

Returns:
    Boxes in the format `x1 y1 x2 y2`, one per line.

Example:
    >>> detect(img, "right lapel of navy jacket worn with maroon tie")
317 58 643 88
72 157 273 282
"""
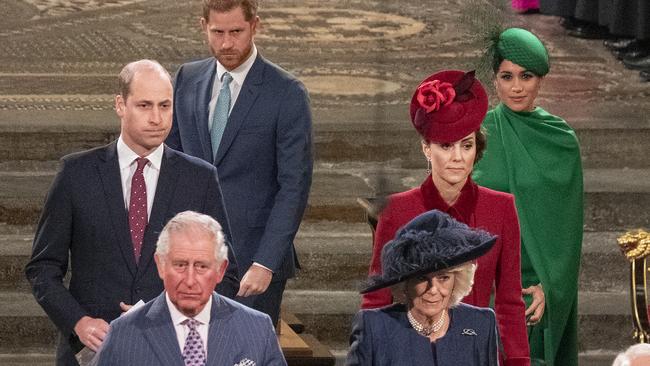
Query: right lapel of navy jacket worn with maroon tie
138 146 179 276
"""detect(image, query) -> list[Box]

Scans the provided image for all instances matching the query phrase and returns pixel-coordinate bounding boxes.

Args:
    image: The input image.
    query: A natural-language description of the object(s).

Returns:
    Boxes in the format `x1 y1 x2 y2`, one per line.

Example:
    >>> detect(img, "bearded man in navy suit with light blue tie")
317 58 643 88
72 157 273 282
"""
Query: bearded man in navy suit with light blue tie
167 0 313 324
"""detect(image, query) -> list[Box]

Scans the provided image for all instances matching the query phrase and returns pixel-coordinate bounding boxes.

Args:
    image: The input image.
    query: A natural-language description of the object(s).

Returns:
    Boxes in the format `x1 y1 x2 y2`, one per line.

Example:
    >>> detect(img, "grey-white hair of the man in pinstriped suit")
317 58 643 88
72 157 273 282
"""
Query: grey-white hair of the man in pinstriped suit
156 211 228 263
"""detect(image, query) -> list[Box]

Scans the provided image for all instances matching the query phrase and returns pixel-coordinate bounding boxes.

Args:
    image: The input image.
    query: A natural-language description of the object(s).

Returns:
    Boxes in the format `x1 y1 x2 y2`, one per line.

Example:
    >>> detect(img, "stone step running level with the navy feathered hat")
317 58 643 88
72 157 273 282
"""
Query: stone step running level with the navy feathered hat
0 217 629 292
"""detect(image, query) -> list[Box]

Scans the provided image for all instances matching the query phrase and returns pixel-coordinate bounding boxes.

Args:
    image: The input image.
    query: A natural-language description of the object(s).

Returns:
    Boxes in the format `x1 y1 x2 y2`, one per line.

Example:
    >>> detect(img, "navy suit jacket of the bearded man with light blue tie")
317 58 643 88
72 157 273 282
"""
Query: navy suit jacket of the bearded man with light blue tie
167 55 313 279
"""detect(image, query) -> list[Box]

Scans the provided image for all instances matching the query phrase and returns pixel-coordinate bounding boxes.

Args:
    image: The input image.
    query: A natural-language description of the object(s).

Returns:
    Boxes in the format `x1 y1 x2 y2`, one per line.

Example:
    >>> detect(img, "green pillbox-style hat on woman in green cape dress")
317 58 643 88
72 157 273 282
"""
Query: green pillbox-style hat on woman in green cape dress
496 28 550 76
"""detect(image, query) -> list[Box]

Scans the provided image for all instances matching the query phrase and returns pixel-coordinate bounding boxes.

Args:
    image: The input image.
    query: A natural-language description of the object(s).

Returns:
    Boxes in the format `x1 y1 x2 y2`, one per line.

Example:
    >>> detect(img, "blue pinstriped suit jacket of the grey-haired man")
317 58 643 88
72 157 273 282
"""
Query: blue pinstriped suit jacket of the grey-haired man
98 293 287 366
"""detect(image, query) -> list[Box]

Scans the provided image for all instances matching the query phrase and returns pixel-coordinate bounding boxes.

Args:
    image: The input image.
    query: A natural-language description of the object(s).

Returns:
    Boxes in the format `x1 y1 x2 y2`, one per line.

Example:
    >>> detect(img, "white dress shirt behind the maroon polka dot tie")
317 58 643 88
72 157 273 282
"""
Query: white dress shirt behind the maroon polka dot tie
117 135 165 219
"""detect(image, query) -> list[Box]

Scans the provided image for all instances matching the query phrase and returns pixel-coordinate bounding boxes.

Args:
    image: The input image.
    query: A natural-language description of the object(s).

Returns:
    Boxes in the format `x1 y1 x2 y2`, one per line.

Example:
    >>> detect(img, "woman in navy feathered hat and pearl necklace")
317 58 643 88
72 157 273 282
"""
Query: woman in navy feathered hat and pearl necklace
347 210 498 366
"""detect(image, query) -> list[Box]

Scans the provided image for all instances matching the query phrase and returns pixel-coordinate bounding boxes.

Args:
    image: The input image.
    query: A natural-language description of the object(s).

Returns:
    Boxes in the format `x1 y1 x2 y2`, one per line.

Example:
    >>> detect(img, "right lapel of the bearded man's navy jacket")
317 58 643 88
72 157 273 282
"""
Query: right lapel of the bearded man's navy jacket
214 54 266 165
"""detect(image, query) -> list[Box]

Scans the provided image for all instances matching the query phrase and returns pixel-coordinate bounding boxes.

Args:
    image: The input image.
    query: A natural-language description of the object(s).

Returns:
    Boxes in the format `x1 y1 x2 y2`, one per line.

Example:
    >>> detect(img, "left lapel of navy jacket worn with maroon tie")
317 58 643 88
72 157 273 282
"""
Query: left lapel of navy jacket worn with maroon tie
98 141 136 276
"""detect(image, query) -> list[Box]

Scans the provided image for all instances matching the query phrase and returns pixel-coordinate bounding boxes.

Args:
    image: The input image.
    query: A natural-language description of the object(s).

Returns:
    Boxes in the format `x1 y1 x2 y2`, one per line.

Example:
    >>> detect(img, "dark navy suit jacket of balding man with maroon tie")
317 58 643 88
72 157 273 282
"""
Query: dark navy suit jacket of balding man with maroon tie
25 142 238 365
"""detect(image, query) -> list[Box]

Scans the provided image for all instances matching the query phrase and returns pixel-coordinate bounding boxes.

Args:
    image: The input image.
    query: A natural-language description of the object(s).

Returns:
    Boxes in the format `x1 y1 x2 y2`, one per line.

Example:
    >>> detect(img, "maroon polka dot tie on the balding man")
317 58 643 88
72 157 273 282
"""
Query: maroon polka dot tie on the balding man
129 158 149 263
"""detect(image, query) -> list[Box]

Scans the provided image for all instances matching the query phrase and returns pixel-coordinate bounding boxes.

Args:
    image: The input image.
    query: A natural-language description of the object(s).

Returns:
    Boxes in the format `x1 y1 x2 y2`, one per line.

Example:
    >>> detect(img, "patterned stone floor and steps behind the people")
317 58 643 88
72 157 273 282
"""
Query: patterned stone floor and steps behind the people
0 0 650 366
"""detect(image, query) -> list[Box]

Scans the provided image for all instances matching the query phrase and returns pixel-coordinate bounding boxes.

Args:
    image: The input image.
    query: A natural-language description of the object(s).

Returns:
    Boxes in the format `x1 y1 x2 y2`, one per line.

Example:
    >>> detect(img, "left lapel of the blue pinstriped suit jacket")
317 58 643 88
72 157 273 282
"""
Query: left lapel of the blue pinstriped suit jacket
143 292 183 365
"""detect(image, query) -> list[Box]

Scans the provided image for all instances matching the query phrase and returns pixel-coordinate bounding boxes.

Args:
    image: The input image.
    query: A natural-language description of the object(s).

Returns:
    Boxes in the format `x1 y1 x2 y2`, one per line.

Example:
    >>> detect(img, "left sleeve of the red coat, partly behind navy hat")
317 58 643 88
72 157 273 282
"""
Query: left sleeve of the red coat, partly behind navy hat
361 206 398 309
